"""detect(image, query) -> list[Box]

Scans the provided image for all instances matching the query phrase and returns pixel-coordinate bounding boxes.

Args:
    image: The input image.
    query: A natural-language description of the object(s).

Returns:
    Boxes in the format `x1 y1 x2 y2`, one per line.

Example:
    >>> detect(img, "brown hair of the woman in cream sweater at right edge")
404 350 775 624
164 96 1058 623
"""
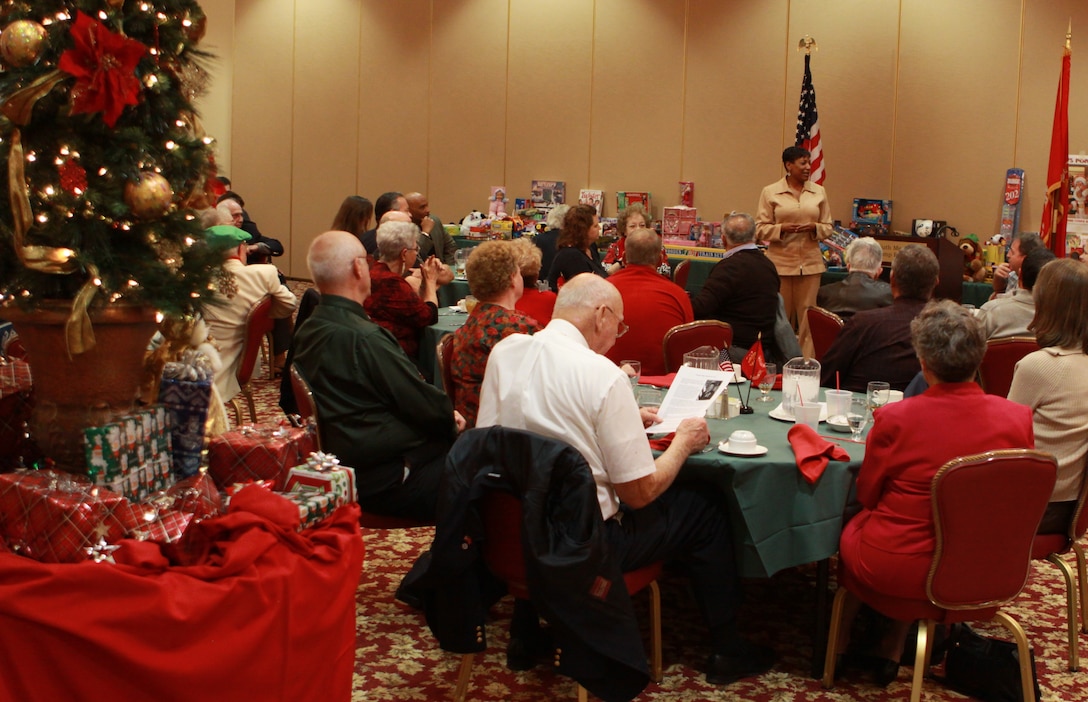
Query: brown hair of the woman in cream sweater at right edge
1028 258 1088 354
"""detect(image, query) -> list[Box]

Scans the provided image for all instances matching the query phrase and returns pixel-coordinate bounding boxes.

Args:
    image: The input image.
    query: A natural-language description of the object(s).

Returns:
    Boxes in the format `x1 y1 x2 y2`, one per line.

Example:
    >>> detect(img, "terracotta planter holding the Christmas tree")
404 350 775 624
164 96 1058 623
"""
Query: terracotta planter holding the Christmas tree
0 301 158 472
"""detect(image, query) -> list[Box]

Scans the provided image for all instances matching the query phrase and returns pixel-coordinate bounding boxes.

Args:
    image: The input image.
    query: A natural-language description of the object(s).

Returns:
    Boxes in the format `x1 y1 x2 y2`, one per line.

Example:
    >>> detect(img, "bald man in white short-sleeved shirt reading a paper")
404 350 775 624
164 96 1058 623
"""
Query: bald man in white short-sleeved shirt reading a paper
477 274 774 685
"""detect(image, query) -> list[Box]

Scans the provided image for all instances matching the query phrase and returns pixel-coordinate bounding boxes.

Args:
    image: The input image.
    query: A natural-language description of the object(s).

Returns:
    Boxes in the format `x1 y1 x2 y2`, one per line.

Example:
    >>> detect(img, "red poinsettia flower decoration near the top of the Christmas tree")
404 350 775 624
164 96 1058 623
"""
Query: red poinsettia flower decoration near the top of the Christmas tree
57 12 147 127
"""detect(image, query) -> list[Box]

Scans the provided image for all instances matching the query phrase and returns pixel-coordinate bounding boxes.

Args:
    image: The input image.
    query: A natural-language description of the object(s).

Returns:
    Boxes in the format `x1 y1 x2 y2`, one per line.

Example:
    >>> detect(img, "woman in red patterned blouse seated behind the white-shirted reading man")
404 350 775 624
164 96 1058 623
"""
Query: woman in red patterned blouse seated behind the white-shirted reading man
450 242 541 427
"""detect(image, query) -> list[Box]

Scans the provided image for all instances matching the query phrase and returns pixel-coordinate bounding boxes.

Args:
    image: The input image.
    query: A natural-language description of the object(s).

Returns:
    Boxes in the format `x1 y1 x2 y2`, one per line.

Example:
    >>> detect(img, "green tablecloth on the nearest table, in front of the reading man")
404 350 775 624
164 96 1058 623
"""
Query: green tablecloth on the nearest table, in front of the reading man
678 384 865 578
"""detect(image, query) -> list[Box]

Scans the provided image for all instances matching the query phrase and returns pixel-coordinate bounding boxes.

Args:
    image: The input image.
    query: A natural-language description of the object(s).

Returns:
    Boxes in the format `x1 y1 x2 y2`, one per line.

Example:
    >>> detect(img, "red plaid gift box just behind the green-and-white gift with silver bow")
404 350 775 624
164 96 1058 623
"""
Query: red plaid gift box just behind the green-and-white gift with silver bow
208 424 316 490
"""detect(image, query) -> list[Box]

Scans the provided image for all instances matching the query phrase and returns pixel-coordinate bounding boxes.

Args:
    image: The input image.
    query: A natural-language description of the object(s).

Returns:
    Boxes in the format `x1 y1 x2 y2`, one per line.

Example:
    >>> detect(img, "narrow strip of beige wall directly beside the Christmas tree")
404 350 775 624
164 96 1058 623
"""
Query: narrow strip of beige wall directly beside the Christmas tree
196 0 234 178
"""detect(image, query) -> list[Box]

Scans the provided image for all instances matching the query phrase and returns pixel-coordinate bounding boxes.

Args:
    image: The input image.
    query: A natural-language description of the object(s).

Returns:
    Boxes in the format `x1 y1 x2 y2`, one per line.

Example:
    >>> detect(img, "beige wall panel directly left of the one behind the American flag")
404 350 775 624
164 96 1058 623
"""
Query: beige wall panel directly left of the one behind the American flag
683 0 787 221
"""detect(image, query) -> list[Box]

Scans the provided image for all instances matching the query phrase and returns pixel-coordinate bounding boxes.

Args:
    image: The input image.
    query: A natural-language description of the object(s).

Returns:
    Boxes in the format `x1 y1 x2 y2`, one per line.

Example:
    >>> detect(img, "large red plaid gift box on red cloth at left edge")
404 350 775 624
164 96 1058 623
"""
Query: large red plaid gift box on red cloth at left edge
0 470 135 563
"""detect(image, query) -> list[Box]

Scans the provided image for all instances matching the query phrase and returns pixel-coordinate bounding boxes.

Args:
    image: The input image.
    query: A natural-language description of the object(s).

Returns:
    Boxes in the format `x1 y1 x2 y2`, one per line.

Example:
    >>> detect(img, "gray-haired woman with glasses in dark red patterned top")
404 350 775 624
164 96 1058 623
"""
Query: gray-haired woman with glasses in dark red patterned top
364 222 442 360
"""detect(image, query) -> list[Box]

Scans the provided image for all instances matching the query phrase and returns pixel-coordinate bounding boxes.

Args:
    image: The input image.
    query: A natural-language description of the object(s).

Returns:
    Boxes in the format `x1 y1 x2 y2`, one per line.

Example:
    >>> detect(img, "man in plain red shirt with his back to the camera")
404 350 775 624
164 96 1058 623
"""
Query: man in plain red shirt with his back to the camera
606 229 695 375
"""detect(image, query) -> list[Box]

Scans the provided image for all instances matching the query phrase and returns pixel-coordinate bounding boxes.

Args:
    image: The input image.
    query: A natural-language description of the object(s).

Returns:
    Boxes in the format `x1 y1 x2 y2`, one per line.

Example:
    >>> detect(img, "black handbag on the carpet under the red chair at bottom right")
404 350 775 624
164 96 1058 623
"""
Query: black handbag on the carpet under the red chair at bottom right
942 624 1039 702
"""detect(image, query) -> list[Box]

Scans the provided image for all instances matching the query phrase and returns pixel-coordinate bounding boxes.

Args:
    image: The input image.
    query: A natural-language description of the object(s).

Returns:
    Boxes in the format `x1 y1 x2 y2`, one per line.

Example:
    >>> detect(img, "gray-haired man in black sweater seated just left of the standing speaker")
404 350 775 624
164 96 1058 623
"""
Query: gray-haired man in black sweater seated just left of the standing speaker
691 212 780 361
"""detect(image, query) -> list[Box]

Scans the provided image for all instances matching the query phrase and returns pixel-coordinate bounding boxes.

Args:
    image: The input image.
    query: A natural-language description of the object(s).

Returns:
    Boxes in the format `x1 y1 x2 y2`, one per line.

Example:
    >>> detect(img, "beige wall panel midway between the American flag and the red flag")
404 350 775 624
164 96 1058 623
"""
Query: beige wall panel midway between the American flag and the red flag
891 0 1021 238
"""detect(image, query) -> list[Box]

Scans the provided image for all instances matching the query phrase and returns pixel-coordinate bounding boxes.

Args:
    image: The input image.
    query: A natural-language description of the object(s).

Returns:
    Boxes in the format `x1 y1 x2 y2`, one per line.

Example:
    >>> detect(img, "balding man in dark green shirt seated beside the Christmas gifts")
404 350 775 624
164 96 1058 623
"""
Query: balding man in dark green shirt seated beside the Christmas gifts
294 232 465 520
